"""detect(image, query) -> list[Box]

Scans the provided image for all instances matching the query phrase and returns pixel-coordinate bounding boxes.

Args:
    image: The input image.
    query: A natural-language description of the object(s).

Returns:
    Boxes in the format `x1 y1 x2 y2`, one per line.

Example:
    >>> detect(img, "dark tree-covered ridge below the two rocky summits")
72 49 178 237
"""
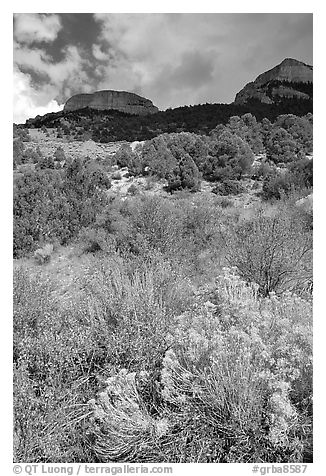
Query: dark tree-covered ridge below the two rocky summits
21 95 312 142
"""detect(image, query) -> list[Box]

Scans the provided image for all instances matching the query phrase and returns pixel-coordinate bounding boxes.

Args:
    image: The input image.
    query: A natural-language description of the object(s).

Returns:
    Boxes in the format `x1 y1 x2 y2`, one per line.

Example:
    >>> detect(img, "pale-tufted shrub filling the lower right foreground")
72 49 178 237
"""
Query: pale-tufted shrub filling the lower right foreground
90 271 312 463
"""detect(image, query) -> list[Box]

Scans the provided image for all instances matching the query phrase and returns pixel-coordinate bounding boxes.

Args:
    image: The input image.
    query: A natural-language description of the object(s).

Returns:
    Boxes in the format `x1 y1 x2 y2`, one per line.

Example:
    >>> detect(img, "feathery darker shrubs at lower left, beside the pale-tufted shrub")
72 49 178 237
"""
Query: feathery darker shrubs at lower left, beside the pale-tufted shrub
14 255 191 462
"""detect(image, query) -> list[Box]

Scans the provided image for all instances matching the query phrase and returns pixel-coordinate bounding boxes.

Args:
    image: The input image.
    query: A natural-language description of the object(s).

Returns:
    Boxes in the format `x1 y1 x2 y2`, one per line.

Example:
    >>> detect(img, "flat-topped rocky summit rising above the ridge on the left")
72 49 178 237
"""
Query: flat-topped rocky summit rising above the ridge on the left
64 90 158 115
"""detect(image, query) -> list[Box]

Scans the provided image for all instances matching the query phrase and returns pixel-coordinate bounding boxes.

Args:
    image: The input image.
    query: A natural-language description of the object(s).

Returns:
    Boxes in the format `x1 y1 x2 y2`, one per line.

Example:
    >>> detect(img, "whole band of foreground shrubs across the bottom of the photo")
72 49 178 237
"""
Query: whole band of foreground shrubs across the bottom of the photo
14 255 312 463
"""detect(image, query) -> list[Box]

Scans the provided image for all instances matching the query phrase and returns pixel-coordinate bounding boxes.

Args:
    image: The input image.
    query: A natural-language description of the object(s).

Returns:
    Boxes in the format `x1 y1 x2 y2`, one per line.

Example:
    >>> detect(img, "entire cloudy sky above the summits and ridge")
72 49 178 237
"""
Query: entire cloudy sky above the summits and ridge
13 13 313 123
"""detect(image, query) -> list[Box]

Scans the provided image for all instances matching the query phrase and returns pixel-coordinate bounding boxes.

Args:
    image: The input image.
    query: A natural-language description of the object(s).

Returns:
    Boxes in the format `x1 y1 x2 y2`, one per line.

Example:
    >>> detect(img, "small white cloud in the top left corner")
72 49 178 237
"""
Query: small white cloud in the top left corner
14 13 62 43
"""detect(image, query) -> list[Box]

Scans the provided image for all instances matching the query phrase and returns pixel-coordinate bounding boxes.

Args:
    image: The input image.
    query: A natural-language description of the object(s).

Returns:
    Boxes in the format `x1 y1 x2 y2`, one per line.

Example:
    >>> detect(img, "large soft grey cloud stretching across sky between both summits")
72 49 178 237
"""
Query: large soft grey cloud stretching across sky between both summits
94 14 312 108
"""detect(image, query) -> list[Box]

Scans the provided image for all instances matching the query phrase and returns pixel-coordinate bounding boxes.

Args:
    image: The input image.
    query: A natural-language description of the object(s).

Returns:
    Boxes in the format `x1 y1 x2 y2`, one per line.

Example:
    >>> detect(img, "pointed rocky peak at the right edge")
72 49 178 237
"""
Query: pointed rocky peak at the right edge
234 58 313 104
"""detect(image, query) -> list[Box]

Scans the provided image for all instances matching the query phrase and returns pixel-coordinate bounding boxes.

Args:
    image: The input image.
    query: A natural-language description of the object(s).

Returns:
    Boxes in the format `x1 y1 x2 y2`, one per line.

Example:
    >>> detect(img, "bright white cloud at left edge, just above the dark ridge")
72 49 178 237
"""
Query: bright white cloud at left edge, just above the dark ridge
13 68 63 124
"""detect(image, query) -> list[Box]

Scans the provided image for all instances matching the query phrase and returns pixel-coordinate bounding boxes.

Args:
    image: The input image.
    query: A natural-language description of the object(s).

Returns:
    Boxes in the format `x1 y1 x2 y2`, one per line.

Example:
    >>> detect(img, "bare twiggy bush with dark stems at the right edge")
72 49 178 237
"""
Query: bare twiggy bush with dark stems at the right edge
225 206 312 296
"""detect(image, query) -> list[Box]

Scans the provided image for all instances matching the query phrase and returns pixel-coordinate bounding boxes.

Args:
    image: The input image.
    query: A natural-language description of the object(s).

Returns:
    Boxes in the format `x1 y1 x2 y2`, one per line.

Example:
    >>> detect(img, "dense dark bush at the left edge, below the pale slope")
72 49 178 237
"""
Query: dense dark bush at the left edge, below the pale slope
14 159 110 257
